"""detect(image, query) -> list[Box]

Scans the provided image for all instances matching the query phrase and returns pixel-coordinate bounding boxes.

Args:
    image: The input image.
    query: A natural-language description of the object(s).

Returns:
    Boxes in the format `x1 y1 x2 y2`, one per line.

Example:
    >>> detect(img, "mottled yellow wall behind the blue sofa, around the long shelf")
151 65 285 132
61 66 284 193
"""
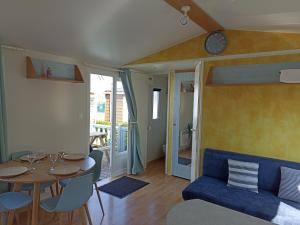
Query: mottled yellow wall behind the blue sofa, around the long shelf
201 54 300 162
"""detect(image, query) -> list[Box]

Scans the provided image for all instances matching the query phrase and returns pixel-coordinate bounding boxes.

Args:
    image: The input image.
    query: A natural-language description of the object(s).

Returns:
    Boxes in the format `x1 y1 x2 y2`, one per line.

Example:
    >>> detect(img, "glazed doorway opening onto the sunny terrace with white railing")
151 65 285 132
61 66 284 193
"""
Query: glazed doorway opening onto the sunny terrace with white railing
90 74 128 179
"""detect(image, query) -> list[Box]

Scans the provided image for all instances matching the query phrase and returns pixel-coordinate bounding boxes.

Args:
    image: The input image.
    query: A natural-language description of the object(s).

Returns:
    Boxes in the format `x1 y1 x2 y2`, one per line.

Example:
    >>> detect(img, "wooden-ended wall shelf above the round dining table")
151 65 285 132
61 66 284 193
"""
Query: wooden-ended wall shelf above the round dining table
26 56 84 83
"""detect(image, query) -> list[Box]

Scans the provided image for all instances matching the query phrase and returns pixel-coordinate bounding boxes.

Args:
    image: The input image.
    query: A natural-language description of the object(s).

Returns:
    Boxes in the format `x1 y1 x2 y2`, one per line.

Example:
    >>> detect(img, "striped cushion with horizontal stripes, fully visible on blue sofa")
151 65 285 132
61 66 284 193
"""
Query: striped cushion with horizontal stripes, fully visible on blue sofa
227 159 259 193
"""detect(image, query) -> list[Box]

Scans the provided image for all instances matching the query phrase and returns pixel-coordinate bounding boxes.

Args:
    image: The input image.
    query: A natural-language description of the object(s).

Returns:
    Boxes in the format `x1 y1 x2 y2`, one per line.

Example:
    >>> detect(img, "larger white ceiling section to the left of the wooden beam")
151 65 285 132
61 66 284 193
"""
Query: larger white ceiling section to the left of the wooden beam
0 0 203 66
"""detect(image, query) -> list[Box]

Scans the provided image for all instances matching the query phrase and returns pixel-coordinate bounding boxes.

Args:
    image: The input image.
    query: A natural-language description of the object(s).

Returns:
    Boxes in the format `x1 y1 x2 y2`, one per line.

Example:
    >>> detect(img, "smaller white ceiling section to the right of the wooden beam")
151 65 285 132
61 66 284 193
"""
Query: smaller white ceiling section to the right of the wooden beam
195 0 300 32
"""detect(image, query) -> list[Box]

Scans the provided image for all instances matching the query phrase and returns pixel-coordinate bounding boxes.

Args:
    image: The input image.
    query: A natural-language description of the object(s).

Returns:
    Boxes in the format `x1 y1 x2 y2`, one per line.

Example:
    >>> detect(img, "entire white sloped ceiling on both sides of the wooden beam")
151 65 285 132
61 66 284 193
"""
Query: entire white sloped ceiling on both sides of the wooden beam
0 0 300 66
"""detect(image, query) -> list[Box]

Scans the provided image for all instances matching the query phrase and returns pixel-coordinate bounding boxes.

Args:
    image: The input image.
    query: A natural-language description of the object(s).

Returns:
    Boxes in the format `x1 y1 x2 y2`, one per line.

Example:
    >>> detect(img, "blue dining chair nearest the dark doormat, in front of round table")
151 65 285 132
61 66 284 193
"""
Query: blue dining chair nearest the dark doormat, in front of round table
40 174 93 225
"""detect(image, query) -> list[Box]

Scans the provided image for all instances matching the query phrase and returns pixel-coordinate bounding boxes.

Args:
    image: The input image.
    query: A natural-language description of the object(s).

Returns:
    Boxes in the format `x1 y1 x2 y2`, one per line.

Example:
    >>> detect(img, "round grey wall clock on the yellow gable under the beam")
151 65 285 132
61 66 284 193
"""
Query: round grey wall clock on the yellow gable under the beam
204 31 227 55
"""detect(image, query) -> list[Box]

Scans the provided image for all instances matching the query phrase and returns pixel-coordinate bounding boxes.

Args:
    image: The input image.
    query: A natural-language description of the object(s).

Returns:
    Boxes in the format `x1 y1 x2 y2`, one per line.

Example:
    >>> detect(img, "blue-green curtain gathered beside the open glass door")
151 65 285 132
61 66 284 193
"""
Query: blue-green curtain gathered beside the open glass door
119 69 144 174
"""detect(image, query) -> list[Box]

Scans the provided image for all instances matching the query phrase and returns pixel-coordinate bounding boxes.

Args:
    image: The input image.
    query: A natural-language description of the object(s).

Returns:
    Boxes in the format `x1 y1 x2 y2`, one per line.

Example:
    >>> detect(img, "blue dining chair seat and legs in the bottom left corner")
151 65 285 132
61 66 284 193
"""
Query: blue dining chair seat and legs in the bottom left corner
0 192 32 224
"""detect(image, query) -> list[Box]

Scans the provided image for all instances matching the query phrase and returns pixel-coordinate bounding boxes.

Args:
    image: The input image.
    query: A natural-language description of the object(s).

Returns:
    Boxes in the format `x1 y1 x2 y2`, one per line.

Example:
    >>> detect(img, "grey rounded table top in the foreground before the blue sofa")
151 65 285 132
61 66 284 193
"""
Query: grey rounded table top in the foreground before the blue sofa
167 199 273 225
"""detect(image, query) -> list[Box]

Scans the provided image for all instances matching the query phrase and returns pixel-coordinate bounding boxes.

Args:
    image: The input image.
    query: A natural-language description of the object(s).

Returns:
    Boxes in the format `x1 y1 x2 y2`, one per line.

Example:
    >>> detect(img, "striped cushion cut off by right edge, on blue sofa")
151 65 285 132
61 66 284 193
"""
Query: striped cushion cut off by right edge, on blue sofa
278 167 300 203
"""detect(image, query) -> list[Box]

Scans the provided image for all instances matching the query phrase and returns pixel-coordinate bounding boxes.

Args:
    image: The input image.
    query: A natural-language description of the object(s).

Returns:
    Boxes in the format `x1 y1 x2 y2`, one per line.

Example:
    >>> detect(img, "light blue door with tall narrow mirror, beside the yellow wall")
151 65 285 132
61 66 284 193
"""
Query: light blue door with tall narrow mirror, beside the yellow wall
172 73 195 180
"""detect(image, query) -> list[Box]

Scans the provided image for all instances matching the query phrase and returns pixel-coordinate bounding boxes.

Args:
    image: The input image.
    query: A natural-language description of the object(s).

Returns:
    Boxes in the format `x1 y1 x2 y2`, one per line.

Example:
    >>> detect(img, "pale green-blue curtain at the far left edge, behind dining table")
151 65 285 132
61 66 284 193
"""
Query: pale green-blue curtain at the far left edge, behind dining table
0 46 8 192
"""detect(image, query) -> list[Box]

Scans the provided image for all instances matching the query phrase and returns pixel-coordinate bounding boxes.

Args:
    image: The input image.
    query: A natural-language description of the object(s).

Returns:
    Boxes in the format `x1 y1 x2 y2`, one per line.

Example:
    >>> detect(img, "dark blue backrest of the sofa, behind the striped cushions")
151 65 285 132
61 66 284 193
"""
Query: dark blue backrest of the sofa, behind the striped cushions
203 149 300 195
